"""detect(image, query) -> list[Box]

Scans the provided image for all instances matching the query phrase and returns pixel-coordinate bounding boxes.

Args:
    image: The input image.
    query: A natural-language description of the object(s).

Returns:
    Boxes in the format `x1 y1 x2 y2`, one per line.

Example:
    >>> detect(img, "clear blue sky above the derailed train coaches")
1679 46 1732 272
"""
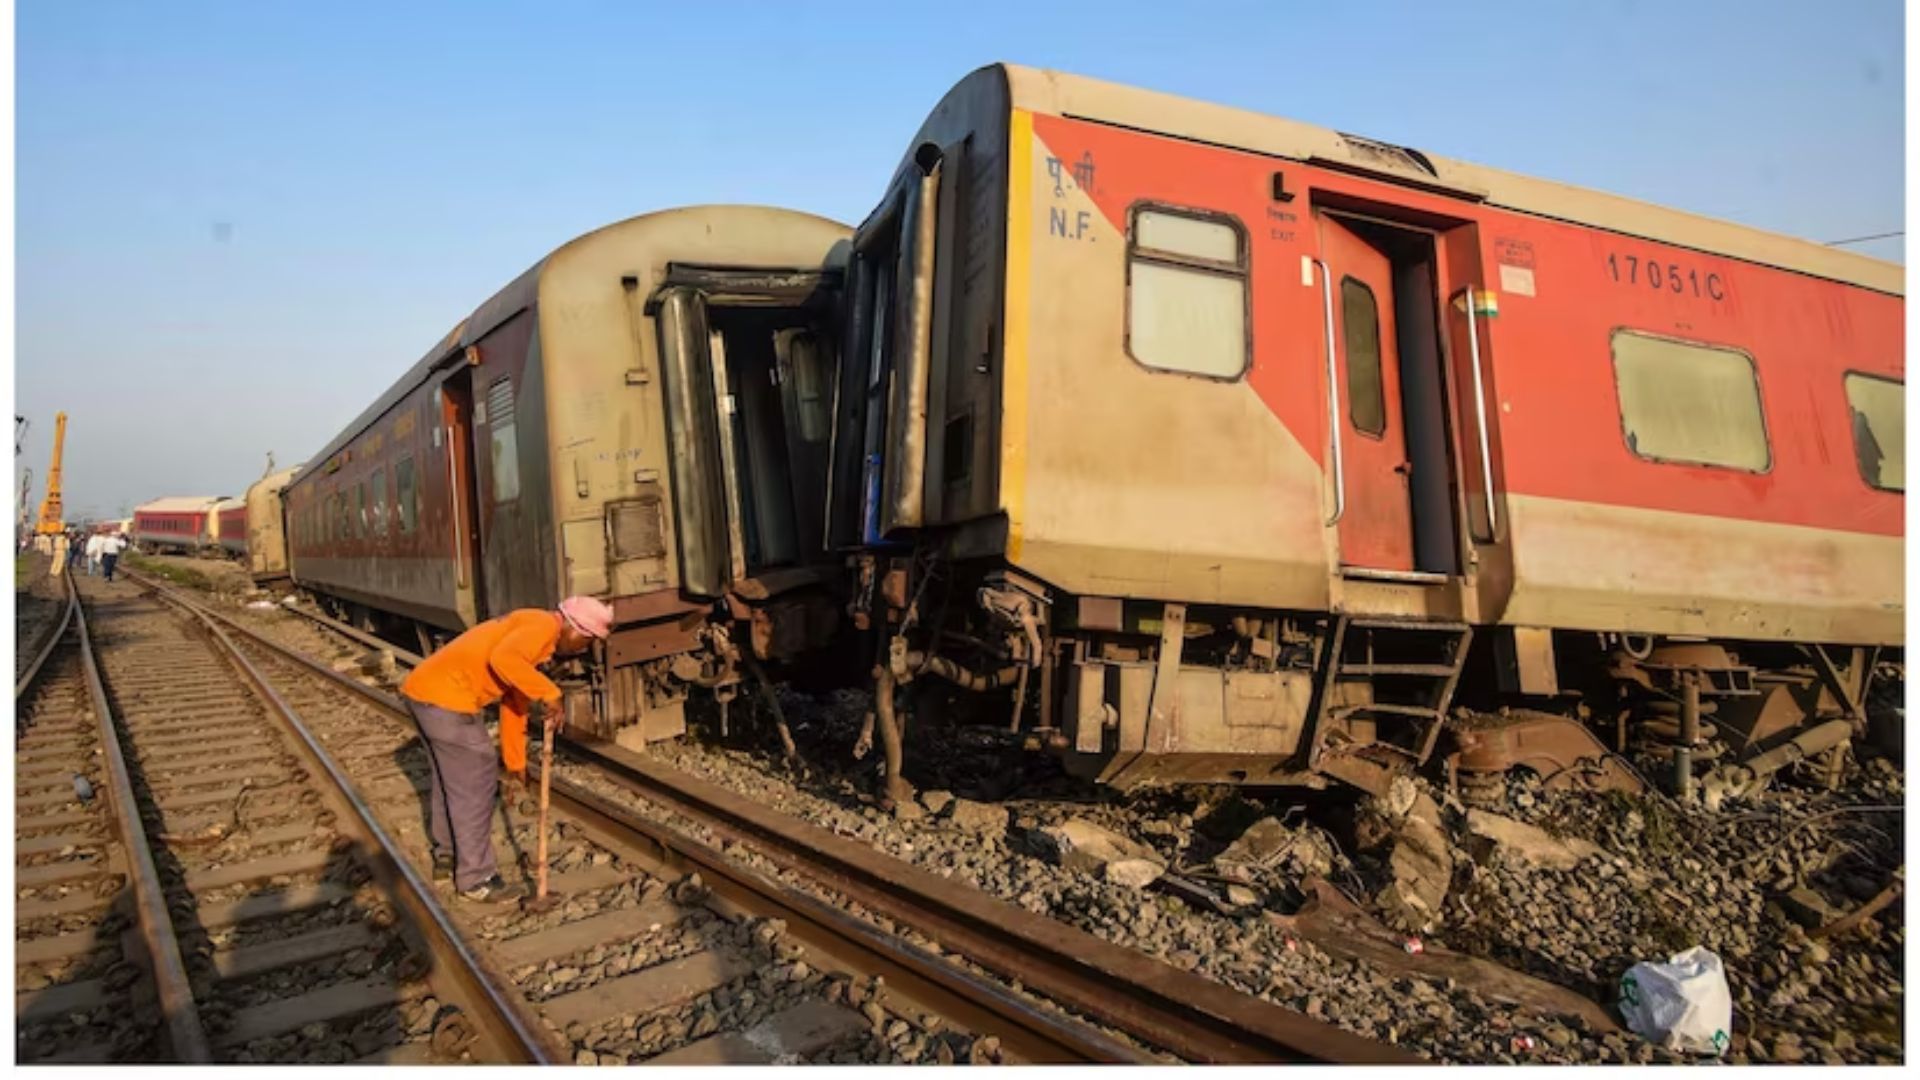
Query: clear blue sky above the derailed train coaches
15 0 1905 515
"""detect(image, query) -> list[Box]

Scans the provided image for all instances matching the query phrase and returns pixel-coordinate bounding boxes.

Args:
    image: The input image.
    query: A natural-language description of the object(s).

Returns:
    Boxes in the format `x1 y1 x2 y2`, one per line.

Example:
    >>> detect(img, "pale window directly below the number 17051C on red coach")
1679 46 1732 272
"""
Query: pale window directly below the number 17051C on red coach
1613 331 1772 473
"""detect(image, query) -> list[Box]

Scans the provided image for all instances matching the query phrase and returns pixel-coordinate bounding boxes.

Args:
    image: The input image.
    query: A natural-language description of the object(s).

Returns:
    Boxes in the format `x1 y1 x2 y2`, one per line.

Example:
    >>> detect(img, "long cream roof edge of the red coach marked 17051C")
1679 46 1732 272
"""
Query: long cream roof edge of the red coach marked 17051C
970 63 1907 296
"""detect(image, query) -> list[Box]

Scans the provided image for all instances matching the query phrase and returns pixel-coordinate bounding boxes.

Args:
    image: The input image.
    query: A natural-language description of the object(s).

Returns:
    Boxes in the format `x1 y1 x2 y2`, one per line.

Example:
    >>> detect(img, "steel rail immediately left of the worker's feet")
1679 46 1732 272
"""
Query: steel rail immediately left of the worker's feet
129 575 556 1065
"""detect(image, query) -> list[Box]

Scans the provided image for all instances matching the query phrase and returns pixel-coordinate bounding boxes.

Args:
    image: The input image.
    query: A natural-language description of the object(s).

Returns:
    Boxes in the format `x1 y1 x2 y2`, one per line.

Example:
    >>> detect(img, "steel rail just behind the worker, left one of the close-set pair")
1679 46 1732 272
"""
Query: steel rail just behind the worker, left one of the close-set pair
165 580 1154 1063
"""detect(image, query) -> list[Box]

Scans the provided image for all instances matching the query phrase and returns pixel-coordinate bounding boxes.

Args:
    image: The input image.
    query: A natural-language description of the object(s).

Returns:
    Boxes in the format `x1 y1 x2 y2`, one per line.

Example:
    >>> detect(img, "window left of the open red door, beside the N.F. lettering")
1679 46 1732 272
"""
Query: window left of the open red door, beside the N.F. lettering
1127 208 1248 379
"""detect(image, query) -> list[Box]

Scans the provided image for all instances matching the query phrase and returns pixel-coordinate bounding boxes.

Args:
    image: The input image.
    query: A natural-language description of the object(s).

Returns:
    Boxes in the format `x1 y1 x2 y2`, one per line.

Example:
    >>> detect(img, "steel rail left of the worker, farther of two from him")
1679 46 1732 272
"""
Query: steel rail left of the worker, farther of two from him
58 575 213 1065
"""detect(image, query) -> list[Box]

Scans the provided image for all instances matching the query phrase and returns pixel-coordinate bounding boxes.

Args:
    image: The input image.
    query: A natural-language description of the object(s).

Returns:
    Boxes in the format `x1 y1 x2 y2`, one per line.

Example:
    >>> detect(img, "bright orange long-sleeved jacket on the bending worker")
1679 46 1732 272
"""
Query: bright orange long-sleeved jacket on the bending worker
399 607 561 773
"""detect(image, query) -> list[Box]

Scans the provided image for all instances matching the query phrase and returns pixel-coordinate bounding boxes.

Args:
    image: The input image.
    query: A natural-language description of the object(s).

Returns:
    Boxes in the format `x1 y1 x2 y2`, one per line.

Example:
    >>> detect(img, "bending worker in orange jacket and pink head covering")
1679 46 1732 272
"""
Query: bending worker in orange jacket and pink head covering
399 596 612 903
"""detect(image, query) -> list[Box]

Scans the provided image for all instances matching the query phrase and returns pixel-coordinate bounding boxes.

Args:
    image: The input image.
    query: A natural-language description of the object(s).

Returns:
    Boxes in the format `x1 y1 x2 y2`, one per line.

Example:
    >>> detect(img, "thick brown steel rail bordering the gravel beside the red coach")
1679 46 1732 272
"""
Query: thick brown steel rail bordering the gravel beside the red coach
168 580 1423 1065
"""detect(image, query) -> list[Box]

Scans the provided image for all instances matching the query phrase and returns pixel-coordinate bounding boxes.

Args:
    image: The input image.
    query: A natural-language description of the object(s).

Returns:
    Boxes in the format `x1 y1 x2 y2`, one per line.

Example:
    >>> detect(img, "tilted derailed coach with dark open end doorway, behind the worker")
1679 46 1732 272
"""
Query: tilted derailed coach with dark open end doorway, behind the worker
284 206 849 746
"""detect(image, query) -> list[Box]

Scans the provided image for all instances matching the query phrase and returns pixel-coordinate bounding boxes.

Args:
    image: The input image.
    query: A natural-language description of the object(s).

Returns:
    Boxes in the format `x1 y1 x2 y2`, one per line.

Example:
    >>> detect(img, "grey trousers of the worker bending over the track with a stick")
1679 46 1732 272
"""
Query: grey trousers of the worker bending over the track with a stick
405 698 499 888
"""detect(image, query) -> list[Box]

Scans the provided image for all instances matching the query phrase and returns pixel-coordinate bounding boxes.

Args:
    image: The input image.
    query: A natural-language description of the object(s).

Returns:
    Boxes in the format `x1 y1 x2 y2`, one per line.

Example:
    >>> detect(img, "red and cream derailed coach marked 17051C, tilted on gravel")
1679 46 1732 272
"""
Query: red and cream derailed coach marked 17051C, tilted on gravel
828 65 1905 798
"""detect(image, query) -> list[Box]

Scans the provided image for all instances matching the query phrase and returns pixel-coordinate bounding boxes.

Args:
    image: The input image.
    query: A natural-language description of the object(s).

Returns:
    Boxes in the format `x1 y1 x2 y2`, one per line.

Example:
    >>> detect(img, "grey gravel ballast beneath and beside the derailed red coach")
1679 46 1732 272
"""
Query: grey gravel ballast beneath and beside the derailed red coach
172 580 1905 1063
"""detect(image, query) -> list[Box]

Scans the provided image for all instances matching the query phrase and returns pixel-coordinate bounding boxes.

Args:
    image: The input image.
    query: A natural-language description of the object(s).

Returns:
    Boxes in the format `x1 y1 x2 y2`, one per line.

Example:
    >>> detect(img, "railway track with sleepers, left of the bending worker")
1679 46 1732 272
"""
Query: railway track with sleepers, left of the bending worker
15 580 538 1063
